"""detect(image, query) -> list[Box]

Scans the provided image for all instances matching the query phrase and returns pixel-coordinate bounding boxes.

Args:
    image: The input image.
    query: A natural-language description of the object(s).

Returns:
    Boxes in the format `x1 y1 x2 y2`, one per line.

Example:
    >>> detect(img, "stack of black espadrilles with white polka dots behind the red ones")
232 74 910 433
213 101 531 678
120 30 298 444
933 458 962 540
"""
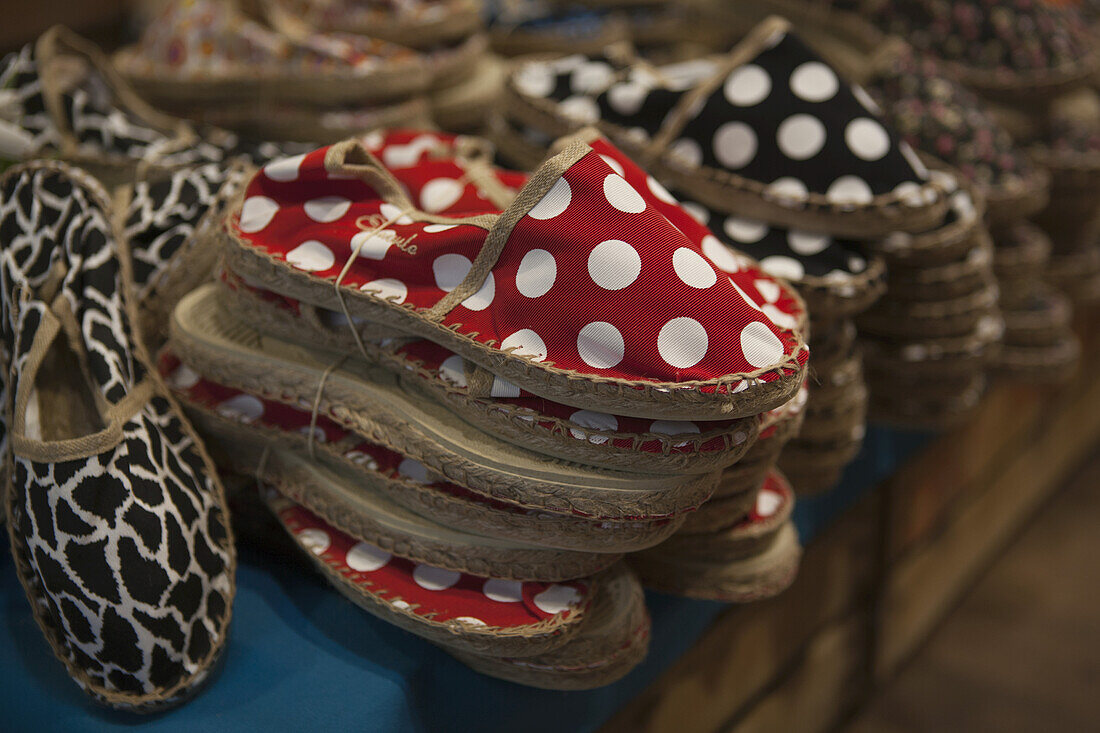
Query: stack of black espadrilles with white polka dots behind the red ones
491 15 968 491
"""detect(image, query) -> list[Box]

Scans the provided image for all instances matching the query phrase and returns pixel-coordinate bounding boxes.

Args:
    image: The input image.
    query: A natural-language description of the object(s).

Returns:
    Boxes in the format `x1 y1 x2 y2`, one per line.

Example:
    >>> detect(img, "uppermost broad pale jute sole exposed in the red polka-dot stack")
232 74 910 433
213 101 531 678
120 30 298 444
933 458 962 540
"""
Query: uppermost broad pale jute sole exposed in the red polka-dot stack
171 284 719 519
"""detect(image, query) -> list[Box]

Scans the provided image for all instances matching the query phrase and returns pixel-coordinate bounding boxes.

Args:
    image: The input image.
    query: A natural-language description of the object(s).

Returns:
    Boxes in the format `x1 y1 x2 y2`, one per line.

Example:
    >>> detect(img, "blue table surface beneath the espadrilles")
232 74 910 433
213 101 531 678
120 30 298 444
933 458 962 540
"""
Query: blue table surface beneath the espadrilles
0 428 930 733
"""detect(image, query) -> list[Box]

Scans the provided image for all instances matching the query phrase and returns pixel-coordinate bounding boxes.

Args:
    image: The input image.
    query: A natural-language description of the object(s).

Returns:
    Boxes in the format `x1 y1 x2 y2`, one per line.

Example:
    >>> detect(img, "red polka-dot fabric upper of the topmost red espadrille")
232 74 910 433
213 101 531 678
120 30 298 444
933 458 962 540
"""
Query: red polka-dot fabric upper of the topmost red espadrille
230 133 806 391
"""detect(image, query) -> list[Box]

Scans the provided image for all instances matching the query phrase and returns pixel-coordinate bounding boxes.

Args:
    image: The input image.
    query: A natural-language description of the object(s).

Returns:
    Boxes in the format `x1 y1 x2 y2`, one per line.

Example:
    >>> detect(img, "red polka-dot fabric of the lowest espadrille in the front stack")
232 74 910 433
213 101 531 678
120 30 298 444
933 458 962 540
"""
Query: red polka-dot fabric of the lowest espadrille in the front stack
272 504 590 628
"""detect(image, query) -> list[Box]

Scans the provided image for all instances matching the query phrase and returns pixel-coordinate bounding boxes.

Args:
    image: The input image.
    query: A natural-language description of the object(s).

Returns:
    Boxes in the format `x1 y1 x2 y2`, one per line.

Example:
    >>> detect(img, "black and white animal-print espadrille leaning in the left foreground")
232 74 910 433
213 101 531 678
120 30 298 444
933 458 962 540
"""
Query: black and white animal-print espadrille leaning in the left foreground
0 162 235 712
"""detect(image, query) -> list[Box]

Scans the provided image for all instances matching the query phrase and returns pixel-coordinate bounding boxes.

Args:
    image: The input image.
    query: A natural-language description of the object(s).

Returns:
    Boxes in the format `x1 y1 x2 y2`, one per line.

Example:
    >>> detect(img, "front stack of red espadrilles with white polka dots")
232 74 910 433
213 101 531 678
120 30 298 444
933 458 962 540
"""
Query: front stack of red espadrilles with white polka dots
160 125 809 688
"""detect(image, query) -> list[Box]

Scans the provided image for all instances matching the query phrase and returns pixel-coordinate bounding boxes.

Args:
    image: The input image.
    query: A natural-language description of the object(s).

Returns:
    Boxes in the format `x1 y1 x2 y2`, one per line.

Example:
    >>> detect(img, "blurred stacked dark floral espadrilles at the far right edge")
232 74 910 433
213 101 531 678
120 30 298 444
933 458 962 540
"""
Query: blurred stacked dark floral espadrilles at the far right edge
853 0 1086 379
